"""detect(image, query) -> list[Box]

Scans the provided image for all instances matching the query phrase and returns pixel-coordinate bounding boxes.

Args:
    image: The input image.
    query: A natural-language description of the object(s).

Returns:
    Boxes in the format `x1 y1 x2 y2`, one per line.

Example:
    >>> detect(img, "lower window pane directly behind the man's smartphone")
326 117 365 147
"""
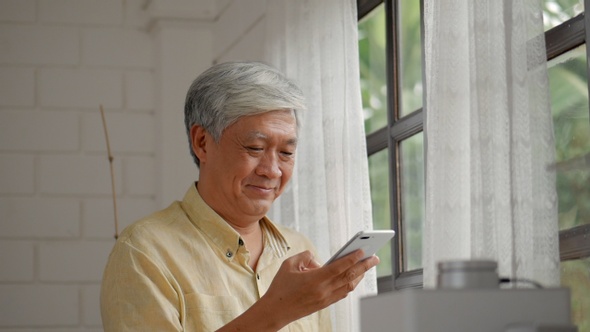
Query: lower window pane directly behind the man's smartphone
369 150 393 277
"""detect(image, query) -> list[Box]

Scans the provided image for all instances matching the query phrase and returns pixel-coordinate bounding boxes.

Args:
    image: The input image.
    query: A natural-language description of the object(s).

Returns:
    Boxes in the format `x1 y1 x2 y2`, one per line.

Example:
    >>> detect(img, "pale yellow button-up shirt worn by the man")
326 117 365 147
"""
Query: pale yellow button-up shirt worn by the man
101 185 331 332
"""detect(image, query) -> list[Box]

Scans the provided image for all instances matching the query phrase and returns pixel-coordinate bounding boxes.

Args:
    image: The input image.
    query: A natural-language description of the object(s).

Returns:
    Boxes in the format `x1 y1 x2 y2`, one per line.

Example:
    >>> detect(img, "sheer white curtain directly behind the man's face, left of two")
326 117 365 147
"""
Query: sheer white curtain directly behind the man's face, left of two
265 0 376 331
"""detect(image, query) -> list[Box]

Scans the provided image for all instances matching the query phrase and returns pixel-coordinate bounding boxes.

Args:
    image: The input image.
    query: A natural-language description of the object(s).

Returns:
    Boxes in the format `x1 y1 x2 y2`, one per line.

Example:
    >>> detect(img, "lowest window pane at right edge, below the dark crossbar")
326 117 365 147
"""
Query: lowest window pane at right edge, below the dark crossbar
561 257 590 332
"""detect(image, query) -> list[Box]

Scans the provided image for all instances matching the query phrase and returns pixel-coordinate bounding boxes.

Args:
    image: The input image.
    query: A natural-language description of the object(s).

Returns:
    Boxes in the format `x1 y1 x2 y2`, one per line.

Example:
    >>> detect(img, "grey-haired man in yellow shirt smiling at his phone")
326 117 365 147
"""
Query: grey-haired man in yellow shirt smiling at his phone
101 62 379 332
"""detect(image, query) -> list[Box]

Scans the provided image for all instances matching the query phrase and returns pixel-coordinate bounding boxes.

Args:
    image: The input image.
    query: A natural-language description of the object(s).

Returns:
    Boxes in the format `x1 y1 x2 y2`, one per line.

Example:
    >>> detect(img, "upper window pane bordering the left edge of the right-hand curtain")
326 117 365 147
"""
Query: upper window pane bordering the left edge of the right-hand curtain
397 1 422 118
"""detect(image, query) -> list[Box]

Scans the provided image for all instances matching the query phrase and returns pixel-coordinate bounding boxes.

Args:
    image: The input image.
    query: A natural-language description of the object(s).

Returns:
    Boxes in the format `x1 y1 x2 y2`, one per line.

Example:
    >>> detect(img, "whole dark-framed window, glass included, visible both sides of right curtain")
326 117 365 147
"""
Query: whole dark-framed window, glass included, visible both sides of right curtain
357 0 590 332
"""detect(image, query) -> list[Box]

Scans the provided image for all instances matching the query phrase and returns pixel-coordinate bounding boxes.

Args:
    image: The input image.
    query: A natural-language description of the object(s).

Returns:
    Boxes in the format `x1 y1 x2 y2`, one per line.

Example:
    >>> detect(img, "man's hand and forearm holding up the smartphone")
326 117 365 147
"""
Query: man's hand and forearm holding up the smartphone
218 250 379 332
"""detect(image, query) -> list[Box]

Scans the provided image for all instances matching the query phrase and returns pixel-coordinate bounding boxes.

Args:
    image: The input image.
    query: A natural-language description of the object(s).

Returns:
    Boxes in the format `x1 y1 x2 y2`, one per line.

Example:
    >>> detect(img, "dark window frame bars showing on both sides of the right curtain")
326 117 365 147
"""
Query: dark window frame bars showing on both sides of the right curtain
357 0 590 293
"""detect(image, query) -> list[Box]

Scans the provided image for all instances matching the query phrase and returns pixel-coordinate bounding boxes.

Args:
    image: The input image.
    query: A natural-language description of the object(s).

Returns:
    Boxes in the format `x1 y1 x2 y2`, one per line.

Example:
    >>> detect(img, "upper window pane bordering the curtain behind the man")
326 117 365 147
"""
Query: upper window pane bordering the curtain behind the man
358 4 387 134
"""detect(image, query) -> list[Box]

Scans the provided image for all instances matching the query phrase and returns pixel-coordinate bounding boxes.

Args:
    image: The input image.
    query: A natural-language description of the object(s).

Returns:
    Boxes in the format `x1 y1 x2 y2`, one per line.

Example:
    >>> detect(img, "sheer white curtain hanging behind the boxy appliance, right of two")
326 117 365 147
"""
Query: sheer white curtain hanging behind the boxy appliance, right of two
423 0 559 287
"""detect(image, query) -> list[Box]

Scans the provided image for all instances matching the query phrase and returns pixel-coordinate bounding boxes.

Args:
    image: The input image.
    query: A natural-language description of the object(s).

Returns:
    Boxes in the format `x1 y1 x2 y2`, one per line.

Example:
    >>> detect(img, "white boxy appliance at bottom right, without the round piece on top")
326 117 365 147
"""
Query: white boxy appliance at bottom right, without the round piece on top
360 288 577 332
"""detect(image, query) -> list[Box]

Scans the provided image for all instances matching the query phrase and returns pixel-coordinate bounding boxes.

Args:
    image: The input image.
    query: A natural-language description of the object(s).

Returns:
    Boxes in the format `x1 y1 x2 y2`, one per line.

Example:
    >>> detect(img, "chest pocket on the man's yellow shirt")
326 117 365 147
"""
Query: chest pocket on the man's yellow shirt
184 293 243 331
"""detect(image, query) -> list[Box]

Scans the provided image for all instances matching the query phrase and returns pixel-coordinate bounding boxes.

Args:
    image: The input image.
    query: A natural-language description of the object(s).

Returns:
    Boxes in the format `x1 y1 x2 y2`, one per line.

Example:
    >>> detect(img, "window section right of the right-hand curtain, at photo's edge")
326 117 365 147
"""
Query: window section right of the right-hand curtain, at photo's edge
543 0 590 332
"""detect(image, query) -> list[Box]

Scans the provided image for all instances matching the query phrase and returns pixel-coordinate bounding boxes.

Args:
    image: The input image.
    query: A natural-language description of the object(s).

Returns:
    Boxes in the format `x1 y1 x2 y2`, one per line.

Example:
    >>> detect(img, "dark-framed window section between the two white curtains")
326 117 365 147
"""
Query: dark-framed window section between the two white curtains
358 1 424 291
